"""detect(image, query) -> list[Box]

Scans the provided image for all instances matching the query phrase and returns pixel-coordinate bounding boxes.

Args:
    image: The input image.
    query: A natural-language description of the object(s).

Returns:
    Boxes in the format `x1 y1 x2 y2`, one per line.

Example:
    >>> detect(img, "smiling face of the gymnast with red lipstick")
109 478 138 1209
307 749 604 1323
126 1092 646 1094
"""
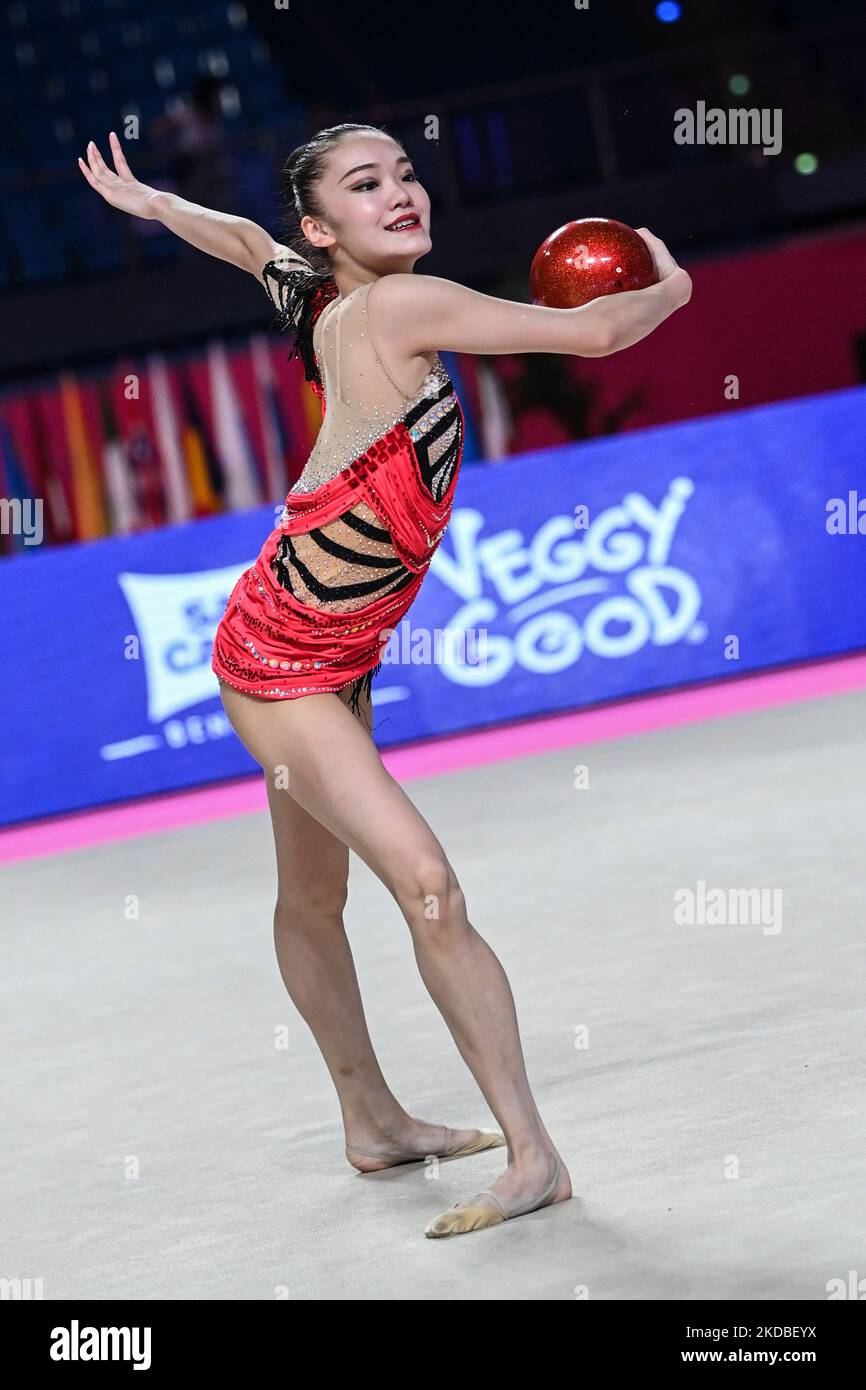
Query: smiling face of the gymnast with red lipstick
300 133 432 275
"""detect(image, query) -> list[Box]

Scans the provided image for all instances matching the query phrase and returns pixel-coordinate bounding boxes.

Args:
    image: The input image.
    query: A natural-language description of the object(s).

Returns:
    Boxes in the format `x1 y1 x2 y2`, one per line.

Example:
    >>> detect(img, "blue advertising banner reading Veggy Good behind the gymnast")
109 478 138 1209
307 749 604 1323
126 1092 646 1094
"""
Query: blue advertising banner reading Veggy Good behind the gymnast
0 388 866 824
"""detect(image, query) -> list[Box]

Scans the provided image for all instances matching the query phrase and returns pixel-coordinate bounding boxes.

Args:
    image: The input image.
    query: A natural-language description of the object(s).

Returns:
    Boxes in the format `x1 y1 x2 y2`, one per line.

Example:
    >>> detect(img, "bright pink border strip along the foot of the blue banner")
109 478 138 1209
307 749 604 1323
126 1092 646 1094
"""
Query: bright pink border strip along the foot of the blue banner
0 656 866 863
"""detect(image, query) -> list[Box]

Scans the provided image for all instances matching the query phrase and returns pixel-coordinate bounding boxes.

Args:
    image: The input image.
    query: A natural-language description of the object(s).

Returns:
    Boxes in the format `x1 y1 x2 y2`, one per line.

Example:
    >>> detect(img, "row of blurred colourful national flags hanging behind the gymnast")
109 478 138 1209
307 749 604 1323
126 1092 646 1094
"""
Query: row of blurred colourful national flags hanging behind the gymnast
0 335 507 555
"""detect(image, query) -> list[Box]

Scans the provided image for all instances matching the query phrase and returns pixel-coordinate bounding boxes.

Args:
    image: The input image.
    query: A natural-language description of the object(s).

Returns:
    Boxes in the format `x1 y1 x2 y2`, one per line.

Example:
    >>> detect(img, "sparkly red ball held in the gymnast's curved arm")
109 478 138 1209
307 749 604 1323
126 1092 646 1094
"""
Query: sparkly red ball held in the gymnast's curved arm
530 217 659 309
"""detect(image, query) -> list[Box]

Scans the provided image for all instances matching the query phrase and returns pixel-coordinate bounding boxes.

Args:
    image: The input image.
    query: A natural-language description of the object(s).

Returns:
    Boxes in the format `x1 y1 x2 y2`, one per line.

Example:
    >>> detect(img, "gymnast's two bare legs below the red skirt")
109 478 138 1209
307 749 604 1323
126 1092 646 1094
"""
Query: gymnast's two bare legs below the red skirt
220 682 571 1223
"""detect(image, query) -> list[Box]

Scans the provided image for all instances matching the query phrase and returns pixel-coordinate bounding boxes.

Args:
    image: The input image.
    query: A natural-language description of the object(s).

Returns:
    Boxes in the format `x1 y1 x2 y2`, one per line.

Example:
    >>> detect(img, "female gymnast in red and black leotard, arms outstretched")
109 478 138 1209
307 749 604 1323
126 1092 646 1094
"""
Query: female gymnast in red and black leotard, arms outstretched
78 124 691 1237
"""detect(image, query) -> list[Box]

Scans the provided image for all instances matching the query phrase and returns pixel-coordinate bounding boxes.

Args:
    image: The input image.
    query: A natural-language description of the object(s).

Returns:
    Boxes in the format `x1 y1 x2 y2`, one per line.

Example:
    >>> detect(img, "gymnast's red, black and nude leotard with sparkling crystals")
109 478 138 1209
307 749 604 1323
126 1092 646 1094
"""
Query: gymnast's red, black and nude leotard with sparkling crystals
211 257 464 710
